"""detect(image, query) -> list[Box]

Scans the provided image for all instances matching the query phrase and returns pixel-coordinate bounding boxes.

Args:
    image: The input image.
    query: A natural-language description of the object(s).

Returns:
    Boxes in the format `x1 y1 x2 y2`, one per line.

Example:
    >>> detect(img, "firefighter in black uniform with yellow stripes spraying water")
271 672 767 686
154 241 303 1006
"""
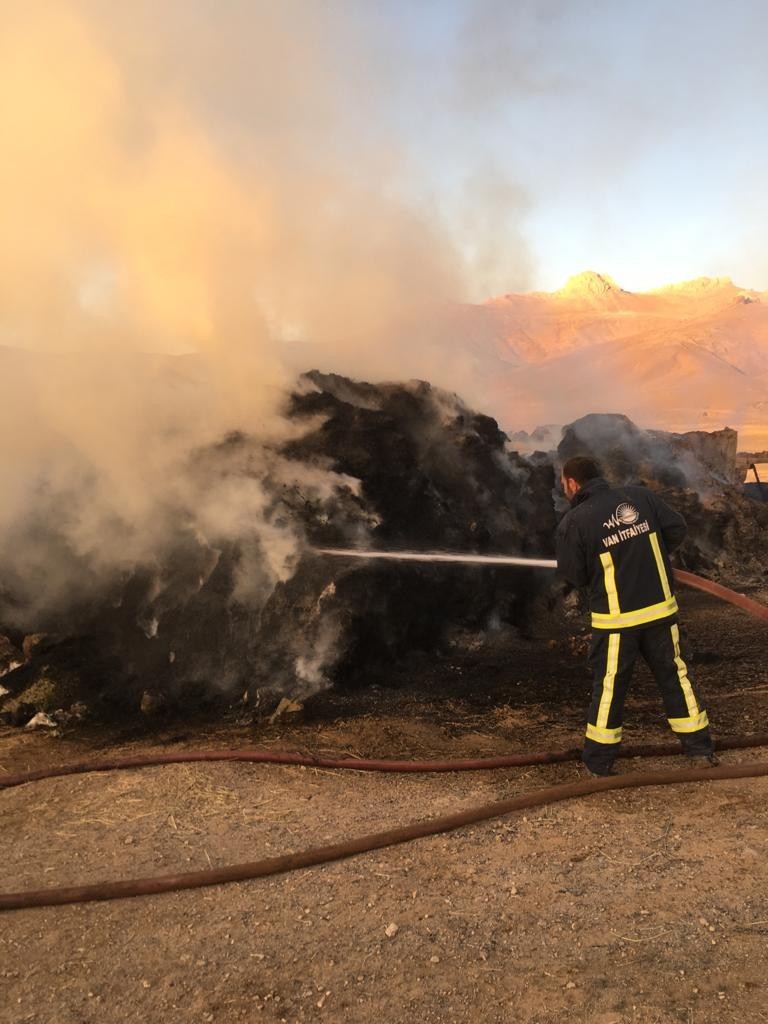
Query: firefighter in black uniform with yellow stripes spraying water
557 456 718 775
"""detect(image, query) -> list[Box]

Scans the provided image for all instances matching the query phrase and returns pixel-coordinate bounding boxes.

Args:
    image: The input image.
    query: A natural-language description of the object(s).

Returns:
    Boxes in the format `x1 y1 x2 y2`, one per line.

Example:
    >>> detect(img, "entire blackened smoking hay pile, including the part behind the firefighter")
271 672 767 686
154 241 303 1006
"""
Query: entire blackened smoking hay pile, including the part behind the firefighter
0 372 768 724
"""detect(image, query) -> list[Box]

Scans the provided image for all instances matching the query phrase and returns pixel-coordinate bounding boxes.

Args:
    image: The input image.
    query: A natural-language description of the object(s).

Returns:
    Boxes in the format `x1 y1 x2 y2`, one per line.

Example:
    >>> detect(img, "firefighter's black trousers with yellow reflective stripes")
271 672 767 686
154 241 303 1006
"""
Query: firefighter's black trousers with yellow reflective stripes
582 618 713 773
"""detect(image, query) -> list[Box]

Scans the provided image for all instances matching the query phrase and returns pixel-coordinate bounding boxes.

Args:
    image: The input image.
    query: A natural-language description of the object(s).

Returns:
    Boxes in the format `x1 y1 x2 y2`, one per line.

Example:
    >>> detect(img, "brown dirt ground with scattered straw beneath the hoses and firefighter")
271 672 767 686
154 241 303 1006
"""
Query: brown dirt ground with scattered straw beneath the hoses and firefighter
0 593 768 1024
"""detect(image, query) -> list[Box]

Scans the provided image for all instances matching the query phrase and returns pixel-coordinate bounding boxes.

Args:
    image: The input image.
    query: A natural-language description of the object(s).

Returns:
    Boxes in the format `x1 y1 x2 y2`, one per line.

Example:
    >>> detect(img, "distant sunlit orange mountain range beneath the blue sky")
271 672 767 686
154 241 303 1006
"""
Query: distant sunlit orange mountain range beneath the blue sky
450 270 768 449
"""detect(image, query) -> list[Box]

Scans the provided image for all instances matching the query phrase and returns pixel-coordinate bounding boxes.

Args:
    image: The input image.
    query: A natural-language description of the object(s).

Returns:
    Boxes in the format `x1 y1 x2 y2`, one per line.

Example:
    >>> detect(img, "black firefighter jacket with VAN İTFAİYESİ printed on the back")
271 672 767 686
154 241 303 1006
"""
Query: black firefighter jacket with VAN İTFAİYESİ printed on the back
557 478 686 631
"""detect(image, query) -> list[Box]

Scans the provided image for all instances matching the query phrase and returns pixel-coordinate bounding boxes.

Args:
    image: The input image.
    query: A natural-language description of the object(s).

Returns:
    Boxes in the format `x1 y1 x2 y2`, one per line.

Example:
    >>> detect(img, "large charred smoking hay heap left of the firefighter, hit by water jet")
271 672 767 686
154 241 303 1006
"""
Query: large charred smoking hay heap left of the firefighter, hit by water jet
0 373 555 715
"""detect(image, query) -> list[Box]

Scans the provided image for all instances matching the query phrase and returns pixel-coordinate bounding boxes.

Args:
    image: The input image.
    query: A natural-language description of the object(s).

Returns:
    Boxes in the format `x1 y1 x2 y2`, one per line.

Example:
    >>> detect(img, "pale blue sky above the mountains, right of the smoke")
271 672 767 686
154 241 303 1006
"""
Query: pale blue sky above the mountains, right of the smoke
351 0 768 290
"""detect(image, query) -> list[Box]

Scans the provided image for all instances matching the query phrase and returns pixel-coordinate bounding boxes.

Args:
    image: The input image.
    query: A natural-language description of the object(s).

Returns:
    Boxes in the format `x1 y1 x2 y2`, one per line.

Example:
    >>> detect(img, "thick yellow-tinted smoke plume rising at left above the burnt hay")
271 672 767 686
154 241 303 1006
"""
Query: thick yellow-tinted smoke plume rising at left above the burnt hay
0 0 518 633
